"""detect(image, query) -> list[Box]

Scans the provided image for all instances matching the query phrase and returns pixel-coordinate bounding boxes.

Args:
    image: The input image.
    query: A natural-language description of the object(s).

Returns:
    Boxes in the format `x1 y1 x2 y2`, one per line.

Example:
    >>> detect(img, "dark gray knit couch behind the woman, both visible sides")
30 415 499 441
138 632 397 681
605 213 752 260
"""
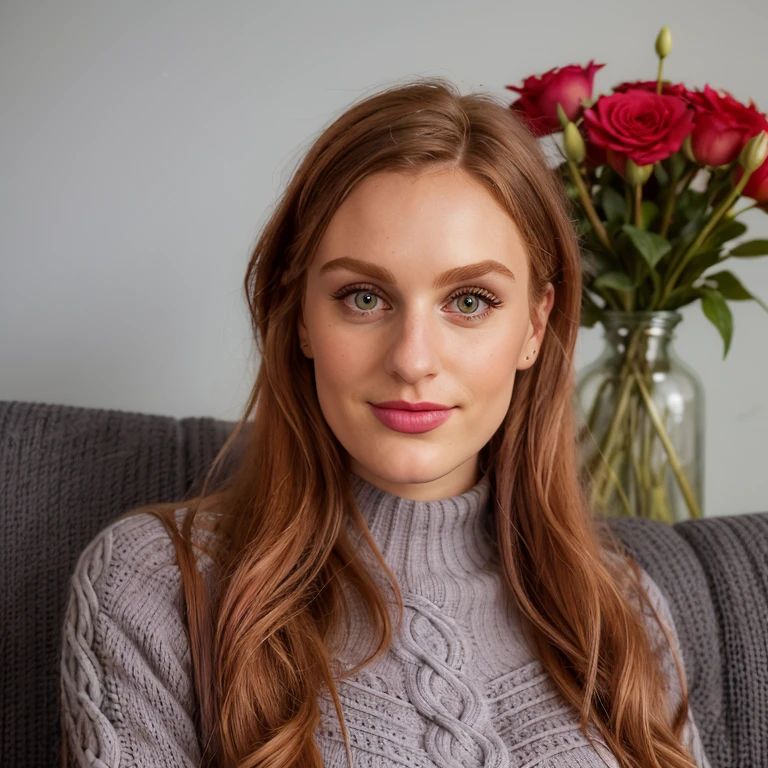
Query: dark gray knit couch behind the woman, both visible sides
0 401 768 768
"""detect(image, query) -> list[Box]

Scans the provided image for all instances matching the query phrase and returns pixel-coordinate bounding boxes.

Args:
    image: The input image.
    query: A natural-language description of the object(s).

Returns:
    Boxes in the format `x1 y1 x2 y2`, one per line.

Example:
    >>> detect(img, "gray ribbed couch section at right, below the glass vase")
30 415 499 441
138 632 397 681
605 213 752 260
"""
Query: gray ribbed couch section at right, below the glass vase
611 512 768 768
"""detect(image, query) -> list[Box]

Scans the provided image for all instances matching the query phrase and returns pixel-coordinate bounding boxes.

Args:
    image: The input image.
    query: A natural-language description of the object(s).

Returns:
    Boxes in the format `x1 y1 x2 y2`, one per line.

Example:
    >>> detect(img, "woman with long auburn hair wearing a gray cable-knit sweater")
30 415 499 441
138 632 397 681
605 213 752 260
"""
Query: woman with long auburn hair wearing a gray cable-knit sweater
57 79 707 768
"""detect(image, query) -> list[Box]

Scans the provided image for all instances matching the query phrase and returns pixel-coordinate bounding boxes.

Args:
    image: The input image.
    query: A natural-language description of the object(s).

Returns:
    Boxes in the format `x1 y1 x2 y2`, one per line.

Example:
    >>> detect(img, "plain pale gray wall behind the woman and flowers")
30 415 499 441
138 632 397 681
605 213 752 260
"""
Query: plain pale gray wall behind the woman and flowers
0 0 768 515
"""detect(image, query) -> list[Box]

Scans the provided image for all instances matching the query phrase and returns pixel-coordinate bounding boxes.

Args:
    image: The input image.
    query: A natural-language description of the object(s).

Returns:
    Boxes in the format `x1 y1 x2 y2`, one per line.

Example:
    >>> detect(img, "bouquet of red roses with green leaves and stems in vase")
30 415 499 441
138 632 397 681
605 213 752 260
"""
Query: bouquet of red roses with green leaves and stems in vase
506 27 768 515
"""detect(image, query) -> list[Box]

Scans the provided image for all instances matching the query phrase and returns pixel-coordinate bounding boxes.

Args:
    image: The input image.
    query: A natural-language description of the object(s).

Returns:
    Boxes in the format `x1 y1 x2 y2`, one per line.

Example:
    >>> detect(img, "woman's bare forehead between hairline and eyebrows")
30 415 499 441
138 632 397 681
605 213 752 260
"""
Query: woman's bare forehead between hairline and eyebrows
314 169 527 272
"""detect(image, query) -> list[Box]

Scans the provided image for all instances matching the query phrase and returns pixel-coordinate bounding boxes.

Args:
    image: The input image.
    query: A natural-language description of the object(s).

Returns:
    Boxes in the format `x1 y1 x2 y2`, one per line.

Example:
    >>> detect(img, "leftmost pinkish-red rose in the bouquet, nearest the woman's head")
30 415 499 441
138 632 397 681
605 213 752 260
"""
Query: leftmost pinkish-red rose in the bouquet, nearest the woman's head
504 61 605 136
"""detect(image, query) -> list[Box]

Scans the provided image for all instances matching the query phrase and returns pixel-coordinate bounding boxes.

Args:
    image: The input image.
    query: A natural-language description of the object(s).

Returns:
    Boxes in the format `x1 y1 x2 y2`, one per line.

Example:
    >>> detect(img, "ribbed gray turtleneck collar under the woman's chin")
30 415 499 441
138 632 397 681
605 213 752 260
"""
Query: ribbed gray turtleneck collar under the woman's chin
350 473 496 586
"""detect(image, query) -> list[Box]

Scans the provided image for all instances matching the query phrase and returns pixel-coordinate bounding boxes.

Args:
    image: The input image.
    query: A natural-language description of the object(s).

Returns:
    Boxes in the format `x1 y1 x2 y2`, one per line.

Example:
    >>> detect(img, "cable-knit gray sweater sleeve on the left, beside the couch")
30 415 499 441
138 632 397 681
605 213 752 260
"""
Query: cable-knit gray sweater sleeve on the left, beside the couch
60 514 207 768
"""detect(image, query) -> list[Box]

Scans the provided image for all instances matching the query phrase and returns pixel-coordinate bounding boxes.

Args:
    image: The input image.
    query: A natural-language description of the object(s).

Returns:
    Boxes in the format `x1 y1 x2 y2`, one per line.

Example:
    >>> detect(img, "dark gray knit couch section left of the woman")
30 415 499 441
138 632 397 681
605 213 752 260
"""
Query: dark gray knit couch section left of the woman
0 401 233 768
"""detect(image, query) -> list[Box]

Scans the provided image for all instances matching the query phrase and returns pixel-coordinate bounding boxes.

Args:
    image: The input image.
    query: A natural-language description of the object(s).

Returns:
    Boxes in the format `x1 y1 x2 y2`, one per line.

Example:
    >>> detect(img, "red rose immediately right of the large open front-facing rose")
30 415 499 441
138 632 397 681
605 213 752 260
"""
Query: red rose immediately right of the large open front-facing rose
688 85 765 166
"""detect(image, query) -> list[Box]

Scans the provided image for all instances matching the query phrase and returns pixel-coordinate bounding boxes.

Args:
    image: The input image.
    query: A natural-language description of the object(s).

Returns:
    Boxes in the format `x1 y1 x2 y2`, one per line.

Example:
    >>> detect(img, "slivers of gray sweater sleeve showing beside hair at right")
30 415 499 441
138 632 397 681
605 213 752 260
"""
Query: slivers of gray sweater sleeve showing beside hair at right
640 567 711 768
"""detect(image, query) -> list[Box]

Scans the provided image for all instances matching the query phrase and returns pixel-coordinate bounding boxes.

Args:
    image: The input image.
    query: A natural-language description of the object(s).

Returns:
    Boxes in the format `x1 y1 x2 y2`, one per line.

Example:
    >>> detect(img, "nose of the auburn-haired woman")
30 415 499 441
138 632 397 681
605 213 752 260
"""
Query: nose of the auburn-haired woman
385 311 443 384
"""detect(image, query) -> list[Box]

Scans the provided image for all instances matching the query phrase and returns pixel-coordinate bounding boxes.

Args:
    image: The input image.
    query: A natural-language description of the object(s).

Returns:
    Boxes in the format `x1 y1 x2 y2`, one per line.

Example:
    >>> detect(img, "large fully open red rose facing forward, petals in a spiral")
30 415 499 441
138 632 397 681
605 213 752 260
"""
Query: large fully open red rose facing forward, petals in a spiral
584 89 694 165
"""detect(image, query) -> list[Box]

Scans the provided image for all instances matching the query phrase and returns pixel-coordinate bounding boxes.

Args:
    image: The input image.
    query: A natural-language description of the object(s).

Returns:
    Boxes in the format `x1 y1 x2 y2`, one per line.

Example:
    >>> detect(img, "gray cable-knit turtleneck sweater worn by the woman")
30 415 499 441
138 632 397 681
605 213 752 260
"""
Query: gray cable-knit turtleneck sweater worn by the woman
60 474 709 768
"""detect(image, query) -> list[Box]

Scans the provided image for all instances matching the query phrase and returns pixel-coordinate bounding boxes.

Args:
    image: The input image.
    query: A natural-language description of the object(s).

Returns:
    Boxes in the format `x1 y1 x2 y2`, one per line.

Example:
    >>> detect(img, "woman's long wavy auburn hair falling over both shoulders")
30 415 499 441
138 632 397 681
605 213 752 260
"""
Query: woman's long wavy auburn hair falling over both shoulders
63 78 695 768
